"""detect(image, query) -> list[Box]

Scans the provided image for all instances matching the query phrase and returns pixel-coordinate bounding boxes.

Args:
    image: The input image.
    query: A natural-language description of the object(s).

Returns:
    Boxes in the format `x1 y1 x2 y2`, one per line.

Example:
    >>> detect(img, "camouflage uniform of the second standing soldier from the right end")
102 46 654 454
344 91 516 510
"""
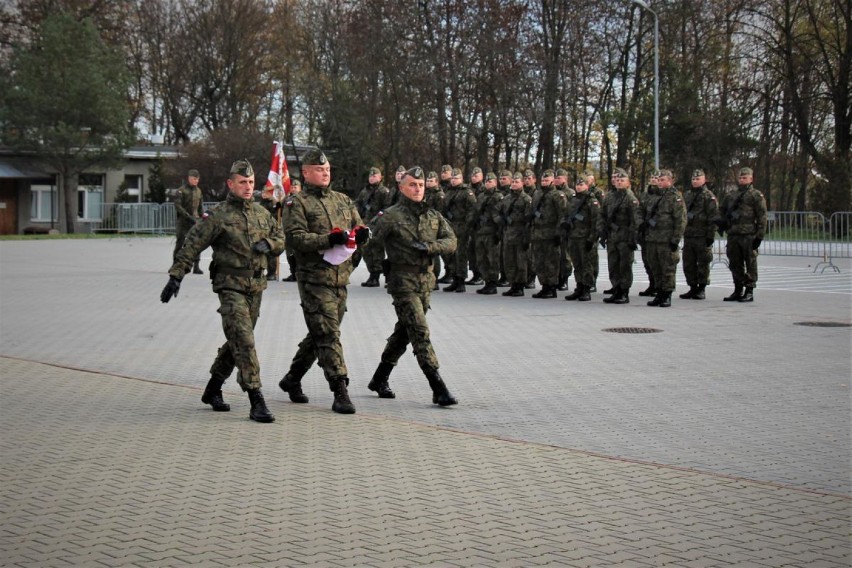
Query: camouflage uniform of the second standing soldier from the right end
683 179 719 291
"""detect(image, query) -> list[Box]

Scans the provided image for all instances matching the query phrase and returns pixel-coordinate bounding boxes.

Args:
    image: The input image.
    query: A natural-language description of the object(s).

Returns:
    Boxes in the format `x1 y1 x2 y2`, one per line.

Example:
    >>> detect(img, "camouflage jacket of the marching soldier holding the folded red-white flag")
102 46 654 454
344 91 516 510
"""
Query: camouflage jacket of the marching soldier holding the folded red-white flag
284 183 363 287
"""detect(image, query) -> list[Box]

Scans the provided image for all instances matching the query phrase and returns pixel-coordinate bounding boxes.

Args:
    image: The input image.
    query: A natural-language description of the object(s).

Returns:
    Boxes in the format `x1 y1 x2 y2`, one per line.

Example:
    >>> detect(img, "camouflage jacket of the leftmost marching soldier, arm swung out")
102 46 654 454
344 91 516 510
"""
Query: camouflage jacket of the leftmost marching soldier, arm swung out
169 193 284 293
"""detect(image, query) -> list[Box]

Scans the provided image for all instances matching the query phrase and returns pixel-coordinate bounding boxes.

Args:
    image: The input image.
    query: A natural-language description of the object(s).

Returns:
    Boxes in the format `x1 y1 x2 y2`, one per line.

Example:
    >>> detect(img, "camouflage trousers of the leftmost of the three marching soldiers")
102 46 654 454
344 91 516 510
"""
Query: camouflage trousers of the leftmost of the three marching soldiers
210 290 263 391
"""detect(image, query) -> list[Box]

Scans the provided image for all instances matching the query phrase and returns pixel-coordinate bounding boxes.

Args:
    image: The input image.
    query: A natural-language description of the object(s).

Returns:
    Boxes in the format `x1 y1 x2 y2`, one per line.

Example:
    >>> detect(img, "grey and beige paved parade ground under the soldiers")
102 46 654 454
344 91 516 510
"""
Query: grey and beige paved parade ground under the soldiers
0 238 852 566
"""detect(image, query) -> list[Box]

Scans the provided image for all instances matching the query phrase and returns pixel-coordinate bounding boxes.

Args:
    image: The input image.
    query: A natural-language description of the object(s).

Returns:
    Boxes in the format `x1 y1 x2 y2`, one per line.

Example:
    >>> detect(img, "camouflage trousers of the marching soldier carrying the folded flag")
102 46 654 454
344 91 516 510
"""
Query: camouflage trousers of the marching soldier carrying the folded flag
290 281 349 381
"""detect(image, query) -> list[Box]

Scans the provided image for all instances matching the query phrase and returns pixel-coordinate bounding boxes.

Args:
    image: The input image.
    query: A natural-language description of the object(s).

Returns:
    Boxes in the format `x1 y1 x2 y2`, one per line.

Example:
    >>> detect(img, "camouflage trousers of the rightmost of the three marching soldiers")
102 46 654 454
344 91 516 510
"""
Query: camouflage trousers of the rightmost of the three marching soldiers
382 272 438 372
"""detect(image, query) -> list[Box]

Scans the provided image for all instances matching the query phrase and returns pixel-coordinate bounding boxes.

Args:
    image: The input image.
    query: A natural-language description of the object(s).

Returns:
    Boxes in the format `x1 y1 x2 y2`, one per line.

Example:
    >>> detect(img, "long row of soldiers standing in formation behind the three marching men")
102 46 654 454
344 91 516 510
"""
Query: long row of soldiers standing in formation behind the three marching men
355 165 766 307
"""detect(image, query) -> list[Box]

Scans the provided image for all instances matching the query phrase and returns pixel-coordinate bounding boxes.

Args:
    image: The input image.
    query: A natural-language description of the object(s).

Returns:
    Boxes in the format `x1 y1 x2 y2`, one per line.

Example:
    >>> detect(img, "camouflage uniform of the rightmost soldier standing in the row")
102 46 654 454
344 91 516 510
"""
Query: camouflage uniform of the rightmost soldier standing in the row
721 184 766 291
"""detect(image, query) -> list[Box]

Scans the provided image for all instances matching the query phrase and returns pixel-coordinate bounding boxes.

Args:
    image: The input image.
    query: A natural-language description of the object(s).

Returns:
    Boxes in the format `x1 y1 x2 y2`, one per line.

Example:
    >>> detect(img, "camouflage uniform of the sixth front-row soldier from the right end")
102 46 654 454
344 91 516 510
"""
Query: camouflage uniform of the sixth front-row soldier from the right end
530 185 568 298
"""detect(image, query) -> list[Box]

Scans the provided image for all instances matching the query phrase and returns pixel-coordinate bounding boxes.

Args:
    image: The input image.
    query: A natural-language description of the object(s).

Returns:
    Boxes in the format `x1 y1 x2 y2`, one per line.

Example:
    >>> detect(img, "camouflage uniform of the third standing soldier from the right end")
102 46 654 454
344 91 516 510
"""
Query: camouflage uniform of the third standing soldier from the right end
643 186 686 307
